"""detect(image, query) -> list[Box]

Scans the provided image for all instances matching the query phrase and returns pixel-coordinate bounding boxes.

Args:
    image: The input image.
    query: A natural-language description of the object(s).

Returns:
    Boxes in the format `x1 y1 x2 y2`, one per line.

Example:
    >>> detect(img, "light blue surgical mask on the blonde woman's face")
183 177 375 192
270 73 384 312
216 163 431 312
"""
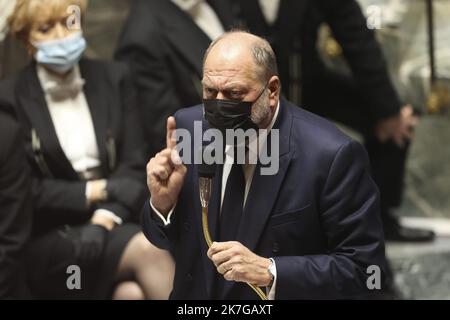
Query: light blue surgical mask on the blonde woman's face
32 32 86 73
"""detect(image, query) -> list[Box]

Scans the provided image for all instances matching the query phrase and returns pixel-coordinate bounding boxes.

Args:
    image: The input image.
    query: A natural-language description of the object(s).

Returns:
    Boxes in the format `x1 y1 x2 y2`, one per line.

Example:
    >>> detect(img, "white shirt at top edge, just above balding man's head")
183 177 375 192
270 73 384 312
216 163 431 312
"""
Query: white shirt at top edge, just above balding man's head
171 0 225 40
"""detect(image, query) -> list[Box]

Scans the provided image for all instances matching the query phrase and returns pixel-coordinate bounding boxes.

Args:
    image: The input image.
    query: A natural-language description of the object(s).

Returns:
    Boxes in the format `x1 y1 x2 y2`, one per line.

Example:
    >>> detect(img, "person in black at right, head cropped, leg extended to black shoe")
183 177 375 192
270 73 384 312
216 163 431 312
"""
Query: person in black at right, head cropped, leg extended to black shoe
232 0 433 241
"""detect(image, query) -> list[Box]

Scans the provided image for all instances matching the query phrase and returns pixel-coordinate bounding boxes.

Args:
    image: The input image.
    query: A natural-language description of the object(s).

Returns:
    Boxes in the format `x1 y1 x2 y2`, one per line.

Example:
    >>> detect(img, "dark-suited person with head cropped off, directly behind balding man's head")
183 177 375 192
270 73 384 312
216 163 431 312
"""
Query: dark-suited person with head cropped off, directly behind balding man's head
115 0 237 156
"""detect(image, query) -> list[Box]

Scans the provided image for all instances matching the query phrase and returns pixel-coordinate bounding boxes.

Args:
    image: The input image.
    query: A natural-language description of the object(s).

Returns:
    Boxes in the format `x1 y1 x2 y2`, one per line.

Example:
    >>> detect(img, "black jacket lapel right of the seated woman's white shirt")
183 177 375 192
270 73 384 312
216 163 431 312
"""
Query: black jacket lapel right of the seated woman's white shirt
80 59 112 173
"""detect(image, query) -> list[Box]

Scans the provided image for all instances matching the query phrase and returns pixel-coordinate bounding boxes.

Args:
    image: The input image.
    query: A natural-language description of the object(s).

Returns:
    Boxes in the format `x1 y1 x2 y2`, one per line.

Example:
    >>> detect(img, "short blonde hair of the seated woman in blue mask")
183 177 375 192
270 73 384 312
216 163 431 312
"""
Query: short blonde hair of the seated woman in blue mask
8 0 88 43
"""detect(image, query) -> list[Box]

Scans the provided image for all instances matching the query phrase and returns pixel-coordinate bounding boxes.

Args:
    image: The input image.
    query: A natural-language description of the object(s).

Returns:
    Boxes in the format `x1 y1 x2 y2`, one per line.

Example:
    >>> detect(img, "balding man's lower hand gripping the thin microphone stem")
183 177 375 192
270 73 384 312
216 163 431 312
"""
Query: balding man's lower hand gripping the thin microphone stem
208 241 272 287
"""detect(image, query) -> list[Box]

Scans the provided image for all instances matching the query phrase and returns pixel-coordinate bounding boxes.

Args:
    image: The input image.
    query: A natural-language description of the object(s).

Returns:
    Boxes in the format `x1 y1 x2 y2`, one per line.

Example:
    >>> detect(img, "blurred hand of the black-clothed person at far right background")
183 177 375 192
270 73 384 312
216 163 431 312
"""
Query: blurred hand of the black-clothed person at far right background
375 104 418 147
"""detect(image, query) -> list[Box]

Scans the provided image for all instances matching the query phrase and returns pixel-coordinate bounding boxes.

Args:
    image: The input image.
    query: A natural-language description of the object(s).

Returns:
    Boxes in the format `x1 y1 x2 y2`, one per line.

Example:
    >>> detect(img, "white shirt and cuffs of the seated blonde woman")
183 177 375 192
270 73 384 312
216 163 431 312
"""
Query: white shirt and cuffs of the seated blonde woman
37 64 122 224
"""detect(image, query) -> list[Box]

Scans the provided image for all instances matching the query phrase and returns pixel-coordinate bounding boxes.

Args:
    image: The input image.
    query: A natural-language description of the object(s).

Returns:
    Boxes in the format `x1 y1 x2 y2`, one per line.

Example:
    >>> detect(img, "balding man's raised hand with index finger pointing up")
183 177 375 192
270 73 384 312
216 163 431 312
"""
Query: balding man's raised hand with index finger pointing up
147 117 187 216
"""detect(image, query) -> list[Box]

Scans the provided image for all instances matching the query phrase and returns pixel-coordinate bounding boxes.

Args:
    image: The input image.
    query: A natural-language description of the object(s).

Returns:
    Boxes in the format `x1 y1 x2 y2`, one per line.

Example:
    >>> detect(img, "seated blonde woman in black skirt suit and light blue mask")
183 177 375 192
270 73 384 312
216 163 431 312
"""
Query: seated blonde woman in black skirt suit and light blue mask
0 0 174 299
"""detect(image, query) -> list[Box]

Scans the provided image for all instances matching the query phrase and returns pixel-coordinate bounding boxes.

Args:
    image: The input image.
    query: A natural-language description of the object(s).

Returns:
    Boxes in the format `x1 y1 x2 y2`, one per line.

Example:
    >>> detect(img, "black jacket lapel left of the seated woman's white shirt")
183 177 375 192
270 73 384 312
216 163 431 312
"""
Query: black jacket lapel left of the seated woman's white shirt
16 63 78 179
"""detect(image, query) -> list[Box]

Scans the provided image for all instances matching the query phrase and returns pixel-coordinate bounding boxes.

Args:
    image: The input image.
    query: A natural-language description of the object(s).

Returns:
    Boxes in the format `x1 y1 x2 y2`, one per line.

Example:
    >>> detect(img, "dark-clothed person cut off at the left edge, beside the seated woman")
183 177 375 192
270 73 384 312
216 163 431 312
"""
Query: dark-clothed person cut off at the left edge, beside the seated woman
0 109 31 299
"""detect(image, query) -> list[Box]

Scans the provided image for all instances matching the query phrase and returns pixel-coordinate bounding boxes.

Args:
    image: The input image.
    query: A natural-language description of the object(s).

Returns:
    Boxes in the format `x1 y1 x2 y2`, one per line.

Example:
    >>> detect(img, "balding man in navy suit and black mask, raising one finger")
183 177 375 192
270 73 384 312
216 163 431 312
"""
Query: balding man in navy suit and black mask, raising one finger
143 32 386 299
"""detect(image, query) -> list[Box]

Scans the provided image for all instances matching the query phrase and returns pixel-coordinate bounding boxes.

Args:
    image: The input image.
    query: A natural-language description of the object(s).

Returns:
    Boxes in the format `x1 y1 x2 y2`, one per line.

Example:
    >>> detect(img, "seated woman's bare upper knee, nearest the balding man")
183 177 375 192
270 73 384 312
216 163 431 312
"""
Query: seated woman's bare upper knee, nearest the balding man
117 233 175 300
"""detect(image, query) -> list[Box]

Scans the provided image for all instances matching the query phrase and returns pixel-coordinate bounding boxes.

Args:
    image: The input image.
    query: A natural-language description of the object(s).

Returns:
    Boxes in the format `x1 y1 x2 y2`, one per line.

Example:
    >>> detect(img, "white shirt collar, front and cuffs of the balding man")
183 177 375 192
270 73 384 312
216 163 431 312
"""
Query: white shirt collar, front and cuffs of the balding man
150 102 280 300
